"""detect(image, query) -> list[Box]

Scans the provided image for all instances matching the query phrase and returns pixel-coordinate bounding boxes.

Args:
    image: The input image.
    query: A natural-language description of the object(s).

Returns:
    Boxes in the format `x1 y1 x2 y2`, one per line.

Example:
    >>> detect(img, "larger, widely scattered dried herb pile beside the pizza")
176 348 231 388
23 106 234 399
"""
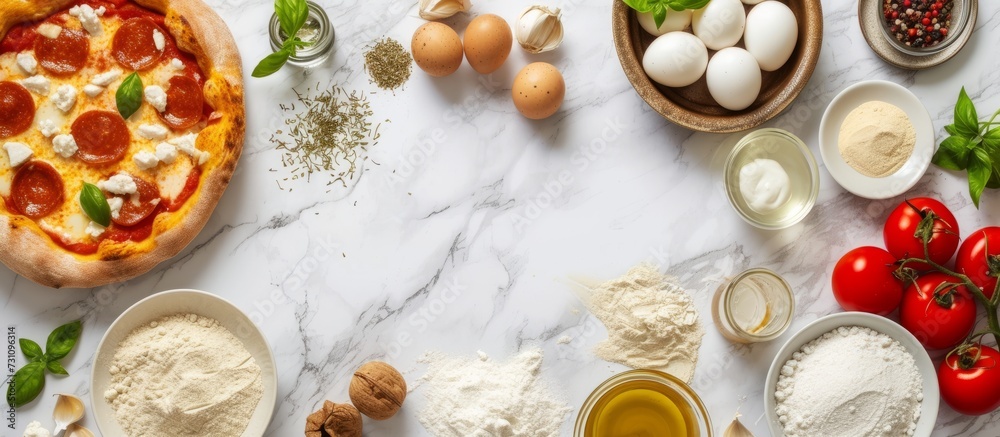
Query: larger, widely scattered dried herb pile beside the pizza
271 84 389 191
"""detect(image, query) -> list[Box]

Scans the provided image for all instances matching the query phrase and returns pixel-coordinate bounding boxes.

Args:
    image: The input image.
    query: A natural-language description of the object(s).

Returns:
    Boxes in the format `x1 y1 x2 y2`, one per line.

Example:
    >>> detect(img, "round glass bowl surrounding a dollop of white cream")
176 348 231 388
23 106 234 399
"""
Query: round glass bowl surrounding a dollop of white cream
723 128 819 230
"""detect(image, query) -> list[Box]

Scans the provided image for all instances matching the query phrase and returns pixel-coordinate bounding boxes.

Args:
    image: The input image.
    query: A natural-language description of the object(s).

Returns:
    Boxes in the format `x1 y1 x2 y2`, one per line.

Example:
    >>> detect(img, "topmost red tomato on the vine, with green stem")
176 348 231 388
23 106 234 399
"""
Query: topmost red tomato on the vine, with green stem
882 197 958 271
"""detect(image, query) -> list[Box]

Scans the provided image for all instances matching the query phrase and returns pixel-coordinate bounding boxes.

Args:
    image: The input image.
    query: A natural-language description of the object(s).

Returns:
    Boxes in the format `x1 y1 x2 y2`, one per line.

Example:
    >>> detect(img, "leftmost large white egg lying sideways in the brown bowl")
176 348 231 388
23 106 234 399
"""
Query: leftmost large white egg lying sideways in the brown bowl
642 32 708 87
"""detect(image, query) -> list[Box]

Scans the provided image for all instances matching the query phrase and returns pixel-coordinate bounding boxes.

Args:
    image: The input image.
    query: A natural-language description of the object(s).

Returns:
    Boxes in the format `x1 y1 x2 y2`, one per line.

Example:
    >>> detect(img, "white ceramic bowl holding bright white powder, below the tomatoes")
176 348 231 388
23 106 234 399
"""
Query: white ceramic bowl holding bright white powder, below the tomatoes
764 312 941 437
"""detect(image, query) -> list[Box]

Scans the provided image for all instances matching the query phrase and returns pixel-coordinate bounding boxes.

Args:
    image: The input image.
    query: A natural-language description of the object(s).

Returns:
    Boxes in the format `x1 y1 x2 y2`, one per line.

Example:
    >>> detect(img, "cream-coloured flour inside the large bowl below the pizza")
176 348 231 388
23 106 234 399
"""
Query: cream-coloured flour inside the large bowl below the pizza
104 314 263 437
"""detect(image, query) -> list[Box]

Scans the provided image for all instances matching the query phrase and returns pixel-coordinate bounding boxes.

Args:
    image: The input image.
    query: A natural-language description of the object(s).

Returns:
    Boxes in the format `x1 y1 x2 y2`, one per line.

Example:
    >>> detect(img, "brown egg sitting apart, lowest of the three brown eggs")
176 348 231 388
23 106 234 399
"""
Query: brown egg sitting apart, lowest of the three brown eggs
511 62 566 120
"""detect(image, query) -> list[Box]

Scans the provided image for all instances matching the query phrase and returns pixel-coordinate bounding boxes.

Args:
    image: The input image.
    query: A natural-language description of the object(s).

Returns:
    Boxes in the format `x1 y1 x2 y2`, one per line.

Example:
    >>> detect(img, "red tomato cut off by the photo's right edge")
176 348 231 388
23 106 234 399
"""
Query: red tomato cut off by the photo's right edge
955 226 1000 297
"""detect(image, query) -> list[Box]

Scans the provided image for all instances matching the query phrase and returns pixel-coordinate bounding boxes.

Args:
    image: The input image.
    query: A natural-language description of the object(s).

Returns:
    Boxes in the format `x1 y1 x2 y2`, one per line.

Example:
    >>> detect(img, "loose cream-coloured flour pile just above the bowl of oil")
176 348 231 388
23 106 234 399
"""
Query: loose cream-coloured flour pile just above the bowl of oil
587 264 705 382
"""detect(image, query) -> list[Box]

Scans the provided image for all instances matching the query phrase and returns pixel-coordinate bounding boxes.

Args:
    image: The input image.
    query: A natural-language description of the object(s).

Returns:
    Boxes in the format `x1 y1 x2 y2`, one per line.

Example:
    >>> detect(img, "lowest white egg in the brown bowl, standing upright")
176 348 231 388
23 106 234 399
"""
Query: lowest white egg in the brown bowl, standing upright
705 47 760 111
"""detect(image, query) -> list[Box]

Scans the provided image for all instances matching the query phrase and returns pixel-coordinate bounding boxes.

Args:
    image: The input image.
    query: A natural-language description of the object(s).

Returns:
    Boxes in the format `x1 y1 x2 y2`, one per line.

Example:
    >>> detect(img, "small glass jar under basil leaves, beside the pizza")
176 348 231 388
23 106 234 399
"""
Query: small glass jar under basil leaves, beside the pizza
269 2 334 68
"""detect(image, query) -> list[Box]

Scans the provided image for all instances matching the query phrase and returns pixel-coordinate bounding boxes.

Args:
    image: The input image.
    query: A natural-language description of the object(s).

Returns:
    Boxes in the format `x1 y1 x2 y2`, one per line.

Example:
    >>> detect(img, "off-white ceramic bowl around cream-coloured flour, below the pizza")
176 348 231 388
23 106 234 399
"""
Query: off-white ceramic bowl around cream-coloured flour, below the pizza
90 290 278 437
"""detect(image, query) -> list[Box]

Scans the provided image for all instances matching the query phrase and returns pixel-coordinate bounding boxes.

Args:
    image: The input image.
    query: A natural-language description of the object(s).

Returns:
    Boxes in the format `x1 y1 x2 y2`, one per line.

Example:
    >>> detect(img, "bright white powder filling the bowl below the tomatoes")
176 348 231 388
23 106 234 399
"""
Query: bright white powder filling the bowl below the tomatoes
774 326 923 437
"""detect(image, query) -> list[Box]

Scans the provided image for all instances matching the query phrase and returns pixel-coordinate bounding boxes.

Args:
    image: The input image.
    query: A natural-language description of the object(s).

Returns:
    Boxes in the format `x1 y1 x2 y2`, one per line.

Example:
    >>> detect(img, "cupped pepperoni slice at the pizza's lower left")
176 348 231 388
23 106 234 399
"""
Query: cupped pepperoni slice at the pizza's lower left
10 161 66 219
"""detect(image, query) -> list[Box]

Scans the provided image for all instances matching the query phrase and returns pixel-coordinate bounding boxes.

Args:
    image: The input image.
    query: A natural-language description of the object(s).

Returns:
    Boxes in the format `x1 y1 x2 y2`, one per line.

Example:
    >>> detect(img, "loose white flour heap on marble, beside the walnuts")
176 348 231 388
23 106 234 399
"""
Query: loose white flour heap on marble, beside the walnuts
419 349 570 437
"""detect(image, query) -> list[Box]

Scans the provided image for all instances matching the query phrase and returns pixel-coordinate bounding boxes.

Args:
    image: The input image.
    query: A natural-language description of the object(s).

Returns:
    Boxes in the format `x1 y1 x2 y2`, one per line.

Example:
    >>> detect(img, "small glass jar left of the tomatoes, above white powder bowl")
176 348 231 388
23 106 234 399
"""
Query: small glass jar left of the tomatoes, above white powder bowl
712 268 795 343
